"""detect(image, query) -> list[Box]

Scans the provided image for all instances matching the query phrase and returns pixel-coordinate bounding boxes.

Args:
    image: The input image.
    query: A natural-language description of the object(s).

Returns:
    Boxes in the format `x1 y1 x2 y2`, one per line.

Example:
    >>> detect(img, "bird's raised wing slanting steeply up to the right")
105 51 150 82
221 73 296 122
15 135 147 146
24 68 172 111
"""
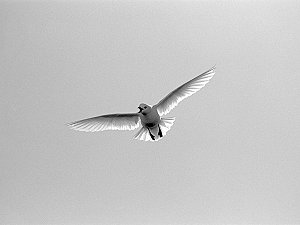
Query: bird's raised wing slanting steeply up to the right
155 67 216 116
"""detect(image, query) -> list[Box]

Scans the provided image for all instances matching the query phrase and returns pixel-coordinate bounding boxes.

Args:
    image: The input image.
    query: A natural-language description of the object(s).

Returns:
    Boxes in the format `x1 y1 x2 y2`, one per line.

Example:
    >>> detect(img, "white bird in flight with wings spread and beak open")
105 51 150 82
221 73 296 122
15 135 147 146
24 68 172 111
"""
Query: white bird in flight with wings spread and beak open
67 66 216 141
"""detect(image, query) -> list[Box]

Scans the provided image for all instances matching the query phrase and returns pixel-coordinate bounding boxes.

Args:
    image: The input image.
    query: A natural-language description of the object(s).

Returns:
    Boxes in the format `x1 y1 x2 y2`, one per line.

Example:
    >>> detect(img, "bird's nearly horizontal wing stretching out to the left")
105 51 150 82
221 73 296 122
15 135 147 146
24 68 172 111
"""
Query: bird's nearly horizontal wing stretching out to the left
67 113 140 132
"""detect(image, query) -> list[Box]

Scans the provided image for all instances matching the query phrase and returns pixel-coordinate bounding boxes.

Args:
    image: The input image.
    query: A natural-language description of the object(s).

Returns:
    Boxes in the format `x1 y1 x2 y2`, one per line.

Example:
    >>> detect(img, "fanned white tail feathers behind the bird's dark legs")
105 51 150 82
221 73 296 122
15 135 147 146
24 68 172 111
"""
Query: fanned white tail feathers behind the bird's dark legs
134 117 175 141
